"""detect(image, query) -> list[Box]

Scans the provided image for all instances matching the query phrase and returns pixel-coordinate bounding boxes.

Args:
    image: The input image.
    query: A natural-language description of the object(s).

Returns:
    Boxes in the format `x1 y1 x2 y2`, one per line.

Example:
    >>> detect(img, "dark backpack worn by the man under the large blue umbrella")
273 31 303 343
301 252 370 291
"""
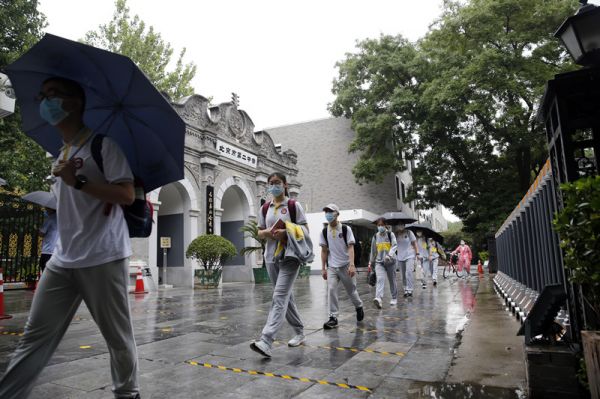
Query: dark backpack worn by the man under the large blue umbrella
91 134 154 237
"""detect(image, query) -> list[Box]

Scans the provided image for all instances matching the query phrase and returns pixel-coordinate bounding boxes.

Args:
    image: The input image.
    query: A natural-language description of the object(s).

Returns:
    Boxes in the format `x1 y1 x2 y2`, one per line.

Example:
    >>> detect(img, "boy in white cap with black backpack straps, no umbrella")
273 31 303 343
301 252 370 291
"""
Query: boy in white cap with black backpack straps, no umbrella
320 204 365 330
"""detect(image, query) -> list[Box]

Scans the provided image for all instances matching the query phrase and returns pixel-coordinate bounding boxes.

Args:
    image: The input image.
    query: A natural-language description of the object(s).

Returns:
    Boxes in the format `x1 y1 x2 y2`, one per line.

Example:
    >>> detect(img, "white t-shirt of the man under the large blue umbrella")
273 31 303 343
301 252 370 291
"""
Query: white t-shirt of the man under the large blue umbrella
51 129 133 268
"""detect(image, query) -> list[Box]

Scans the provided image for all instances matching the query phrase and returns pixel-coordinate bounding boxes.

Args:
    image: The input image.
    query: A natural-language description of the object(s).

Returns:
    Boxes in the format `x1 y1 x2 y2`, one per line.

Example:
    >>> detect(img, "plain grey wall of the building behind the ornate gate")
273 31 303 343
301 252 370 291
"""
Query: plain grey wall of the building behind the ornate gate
265 118 397 213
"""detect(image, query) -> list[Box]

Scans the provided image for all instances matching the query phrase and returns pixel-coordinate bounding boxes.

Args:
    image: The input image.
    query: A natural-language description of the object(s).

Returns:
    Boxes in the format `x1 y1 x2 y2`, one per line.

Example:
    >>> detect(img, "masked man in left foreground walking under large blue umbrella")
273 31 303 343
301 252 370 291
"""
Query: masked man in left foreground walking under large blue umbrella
0 77 139 399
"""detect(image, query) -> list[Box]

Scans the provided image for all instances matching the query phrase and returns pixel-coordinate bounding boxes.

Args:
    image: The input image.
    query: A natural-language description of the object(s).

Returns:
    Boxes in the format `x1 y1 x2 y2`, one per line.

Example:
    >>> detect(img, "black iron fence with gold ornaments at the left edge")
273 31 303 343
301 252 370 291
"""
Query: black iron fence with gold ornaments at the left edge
0 193 44 283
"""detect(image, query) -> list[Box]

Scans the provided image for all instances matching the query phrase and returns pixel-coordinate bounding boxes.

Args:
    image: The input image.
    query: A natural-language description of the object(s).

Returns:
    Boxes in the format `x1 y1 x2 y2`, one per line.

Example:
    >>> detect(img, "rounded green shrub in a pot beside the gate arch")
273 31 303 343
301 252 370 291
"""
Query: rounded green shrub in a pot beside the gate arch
185 234 237 288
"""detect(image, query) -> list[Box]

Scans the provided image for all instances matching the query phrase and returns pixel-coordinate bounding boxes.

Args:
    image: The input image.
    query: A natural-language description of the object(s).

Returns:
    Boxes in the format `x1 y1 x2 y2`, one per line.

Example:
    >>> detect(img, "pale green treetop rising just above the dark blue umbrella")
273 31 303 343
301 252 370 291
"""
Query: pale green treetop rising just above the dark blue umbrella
83 0 196 99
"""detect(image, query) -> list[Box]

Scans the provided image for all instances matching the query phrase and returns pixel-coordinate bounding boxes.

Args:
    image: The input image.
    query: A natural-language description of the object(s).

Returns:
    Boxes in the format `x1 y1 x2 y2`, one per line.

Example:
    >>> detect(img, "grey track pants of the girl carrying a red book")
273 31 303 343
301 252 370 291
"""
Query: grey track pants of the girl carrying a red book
261 258 304 345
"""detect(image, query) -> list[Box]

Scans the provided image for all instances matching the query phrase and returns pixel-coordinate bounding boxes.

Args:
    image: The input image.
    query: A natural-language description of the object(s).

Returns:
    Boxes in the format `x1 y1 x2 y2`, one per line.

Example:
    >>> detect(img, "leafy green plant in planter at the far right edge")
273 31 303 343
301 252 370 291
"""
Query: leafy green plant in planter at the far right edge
554 176 600 397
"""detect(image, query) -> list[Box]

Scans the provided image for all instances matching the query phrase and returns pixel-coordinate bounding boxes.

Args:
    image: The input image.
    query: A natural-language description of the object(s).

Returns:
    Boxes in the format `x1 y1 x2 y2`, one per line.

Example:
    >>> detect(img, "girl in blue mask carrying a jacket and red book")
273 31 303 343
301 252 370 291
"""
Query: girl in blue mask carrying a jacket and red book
250 173 312 357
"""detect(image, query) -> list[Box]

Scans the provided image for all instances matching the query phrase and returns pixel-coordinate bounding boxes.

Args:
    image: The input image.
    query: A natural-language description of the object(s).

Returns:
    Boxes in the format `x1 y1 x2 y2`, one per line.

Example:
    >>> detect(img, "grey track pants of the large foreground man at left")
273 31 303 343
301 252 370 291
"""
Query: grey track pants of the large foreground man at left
0 259 138 399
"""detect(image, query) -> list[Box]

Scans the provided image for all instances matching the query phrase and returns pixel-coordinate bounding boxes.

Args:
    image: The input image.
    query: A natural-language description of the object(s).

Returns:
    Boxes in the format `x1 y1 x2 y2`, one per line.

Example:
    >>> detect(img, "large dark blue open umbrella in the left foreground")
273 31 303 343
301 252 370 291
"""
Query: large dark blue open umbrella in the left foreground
6 34 185 191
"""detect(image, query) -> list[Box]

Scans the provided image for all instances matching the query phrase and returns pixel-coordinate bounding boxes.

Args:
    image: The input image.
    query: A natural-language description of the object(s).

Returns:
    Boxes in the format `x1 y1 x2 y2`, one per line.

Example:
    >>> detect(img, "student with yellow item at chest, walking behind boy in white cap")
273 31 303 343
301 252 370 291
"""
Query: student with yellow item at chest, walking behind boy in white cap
369 218 398 309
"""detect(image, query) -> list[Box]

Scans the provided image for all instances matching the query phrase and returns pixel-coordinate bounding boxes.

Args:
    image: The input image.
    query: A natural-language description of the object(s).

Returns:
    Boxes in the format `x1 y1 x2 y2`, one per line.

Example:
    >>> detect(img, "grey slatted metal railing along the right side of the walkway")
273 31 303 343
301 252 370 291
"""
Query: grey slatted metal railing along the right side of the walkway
496 160 564 320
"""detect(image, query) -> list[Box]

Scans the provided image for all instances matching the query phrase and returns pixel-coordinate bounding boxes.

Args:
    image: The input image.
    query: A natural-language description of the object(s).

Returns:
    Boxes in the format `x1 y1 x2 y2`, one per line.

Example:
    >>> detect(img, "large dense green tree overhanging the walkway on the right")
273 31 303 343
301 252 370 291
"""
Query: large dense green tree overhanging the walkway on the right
329 0 577 247
